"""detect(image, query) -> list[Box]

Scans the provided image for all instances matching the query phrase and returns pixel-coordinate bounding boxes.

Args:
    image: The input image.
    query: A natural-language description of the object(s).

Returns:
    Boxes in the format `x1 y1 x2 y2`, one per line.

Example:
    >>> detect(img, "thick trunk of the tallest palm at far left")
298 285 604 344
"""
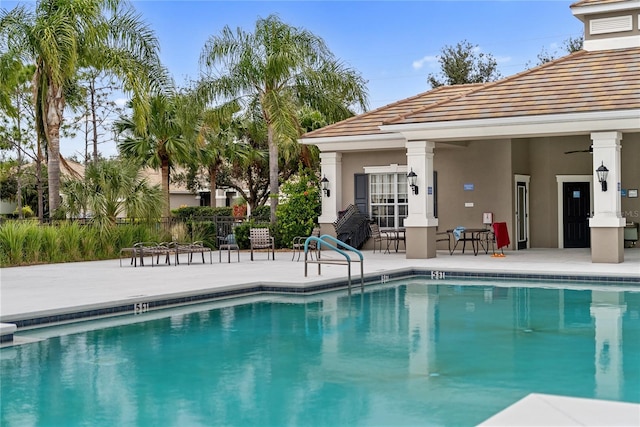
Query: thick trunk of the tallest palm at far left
45 85 64 217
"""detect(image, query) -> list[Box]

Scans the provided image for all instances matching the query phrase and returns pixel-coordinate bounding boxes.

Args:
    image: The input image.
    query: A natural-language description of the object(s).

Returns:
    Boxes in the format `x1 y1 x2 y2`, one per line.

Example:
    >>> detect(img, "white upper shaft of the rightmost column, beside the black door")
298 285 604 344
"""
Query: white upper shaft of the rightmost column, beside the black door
589 132 625 228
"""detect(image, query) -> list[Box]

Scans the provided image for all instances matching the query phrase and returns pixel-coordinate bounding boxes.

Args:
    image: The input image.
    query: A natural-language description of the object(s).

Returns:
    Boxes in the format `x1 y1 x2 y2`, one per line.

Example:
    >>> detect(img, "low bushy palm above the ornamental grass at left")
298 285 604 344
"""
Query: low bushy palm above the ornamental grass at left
61 159 162 226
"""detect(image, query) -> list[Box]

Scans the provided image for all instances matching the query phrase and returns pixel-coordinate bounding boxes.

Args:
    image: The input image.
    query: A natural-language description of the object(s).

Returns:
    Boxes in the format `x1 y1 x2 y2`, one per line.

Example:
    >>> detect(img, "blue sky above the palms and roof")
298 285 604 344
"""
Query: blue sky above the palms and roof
0 0 583 155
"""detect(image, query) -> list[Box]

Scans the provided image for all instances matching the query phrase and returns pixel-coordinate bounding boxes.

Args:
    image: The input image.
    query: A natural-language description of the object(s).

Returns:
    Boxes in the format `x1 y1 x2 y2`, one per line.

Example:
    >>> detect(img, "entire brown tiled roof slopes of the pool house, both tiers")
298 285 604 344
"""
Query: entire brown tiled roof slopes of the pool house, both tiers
304 48 640 138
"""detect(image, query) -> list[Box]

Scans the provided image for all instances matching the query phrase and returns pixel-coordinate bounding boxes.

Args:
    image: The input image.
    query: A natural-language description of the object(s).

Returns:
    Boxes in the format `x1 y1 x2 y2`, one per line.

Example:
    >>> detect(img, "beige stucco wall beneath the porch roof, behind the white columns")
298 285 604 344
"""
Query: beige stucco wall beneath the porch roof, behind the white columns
330 133 640 249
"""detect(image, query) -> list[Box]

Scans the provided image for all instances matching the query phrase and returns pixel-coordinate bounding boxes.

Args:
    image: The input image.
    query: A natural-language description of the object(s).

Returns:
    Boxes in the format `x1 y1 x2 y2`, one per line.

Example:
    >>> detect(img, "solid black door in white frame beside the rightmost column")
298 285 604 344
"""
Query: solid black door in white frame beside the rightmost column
562 182 591 248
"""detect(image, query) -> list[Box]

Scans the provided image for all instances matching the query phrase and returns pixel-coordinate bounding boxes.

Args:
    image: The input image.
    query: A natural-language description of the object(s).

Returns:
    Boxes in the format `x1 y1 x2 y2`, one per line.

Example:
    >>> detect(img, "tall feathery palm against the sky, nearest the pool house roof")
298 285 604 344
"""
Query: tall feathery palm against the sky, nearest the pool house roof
200 15 367 223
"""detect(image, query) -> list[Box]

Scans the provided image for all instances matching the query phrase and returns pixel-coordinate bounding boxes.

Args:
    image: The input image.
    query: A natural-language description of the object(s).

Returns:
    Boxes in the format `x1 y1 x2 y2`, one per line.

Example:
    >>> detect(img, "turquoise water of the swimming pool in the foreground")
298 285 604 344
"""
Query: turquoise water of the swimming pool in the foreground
0 279 640 426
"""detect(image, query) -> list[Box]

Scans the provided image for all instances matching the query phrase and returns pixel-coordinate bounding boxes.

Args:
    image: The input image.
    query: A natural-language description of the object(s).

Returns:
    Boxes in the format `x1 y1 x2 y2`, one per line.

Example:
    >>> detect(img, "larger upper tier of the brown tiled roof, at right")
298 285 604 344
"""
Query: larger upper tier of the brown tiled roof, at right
387 48 640 123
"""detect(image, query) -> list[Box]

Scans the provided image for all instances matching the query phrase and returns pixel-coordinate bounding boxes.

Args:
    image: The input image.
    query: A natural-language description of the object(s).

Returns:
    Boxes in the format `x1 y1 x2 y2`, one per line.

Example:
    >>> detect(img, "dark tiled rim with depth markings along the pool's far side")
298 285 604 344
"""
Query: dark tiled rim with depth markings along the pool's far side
0 267 640 330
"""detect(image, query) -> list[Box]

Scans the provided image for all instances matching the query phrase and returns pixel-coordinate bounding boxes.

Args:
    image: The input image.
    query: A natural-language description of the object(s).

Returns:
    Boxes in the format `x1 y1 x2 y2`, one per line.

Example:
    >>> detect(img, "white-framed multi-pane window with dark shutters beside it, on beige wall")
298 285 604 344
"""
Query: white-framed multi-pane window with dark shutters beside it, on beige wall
369 172 408 228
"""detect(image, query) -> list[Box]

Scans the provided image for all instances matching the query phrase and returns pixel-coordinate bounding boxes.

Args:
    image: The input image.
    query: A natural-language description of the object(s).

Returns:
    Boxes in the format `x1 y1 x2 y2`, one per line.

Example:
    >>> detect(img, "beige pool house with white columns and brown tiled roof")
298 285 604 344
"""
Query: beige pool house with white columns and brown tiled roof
301 0 640 263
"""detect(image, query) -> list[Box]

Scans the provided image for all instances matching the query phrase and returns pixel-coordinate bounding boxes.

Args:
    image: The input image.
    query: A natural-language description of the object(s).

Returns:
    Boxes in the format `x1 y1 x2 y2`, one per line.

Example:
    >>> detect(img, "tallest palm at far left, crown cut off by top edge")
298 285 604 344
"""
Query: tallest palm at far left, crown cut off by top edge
0 0 166 214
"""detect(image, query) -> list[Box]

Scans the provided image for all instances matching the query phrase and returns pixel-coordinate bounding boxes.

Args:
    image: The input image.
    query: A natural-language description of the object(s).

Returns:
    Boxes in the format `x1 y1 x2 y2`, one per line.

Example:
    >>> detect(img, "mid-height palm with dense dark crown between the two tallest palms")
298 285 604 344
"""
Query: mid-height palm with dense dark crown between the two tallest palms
114 94 200 218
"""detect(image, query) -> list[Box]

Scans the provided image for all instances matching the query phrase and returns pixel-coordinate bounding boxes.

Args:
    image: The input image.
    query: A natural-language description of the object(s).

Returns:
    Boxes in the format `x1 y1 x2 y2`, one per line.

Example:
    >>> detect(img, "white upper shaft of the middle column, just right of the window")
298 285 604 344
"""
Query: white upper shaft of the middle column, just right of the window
404 141 438 227
